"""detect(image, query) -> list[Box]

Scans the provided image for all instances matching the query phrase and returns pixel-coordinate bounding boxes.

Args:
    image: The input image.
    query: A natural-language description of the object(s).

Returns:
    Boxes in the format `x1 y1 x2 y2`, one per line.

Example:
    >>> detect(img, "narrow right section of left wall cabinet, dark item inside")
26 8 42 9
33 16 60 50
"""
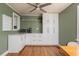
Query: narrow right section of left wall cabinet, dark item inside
13 12 20 31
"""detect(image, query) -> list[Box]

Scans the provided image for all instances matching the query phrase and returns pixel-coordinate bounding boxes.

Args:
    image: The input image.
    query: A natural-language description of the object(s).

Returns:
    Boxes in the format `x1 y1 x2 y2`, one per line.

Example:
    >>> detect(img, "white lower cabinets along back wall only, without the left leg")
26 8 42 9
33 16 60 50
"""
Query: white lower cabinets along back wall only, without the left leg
26 34 58 45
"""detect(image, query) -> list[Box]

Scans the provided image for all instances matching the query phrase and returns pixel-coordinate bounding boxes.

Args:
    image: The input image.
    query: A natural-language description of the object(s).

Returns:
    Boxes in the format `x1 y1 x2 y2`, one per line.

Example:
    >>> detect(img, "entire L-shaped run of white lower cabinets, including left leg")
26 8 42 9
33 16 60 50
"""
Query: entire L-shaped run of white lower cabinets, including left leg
8 34 58 52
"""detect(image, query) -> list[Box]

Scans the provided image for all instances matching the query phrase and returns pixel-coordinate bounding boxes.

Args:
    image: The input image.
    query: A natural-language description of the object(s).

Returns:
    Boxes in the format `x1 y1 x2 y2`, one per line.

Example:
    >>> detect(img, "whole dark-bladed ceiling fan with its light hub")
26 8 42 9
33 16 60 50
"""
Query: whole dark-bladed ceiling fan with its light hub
27 3 51 13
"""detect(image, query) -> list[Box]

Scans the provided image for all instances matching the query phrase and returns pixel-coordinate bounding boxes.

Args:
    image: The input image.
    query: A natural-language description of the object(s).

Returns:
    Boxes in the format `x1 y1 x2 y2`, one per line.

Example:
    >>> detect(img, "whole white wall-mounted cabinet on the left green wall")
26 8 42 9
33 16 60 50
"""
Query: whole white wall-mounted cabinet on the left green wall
2 12 20 31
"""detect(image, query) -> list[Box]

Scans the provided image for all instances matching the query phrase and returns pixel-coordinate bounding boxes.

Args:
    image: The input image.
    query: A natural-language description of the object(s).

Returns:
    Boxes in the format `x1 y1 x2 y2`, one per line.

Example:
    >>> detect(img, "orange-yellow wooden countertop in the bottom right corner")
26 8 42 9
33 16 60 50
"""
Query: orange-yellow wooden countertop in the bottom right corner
60 46 79 56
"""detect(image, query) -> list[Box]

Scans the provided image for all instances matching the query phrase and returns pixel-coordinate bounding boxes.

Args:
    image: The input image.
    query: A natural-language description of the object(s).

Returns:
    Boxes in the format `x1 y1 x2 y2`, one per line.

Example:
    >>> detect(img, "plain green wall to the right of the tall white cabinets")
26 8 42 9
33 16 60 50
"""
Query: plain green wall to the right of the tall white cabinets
59 3 78 44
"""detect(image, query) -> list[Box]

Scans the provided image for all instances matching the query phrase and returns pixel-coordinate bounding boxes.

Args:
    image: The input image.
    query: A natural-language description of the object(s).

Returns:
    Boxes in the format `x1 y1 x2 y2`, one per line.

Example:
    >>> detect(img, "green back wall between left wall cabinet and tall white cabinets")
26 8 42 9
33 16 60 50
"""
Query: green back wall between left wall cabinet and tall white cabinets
21 16 42 33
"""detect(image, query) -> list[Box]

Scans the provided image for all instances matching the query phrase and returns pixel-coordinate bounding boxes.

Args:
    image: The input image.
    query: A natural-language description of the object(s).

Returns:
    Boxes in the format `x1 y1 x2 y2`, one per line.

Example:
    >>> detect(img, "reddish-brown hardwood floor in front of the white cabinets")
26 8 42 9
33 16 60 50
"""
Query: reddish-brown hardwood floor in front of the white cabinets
7 46 61 56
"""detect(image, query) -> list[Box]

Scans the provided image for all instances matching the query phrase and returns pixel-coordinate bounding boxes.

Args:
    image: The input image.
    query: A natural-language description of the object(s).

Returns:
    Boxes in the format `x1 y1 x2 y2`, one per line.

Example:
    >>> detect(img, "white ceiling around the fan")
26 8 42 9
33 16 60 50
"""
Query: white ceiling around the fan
7 3 71 16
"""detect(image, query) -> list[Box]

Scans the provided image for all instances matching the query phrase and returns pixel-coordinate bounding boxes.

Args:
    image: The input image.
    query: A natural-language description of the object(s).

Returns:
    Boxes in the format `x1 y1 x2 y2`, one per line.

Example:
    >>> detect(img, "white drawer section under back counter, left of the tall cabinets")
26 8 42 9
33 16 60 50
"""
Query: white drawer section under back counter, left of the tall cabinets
26 34 43 45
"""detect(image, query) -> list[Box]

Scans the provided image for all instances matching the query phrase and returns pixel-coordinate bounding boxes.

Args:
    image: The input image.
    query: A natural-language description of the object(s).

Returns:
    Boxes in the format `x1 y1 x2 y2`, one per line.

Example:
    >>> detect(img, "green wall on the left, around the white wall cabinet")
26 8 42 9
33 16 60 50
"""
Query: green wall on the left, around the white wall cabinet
0 3 17 54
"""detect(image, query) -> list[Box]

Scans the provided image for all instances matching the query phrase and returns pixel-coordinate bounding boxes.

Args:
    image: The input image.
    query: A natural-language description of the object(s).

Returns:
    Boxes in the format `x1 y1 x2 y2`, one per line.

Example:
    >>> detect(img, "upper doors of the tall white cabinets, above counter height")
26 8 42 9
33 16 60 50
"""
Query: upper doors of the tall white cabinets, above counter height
43 13 58 34
